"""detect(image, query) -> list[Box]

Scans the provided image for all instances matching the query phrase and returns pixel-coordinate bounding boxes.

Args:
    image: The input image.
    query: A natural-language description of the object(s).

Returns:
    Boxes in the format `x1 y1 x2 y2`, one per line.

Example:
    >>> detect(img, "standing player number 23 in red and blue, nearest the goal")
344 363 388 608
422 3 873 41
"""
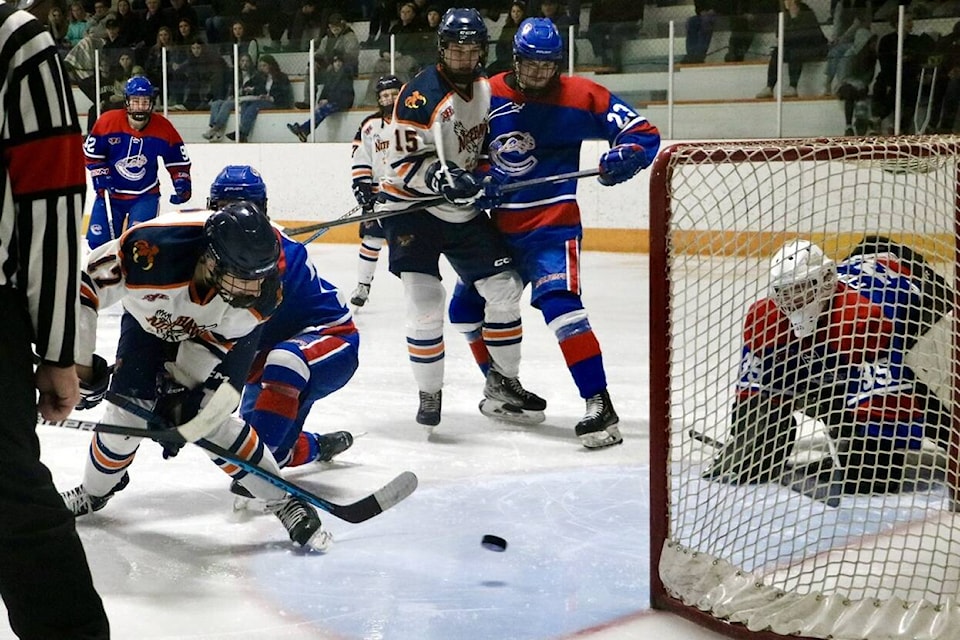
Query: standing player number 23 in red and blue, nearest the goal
450 18 660 449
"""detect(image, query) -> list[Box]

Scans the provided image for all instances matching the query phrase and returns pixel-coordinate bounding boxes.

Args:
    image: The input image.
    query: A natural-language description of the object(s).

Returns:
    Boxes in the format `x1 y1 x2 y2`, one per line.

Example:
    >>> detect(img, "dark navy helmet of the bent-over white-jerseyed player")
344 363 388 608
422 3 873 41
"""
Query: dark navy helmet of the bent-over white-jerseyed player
203 201 280 308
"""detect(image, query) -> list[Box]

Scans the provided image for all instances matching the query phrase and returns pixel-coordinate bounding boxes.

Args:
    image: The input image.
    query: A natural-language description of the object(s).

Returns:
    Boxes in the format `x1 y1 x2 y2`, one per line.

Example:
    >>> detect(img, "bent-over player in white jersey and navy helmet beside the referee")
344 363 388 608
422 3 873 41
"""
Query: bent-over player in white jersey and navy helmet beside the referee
61 203 331 549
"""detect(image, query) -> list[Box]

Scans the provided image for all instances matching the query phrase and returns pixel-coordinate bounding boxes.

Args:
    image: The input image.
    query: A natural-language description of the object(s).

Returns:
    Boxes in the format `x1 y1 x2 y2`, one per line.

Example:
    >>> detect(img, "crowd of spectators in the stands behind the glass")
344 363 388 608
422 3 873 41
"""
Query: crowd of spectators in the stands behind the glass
31 0 960 140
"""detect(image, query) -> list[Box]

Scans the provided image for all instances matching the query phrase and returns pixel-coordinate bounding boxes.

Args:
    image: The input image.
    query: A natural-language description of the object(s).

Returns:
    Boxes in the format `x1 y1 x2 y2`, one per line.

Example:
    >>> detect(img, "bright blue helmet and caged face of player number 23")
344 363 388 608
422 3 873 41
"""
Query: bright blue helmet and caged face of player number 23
513 18 563 94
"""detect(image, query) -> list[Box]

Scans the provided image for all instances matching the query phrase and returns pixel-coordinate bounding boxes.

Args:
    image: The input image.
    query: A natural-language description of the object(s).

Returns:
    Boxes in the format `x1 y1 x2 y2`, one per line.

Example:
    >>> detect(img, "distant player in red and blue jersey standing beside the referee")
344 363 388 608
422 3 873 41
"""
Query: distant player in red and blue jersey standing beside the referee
83 76 192 249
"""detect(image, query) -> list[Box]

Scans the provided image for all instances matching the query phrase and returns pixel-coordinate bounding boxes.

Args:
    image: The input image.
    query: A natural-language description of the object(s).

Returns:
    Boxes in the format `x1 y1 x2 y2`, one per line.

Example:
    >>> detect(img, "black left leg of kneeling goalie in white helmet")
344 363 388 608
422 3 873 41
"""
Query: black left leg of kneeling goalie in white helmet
703 394 797 484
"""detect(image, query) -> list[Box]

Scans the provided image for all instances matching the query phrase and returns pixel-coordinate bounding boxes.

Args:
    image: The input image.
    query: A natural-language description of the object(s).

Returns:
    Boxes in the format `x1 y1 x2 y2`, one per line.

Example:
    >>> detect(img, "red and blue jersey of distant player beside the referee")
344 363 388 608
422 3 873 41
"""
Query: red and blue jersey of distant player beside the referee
83 109 190 199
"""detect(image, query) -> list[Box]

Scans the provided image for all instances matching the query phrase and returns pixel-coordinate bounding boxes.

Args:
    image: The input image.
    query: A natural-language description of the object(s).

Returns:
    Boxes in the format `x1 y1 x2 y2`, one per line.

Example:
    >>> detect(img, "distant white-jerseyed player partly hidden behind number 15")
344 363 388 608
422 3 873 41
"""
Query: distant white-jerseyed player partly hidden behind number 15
350 75 403 307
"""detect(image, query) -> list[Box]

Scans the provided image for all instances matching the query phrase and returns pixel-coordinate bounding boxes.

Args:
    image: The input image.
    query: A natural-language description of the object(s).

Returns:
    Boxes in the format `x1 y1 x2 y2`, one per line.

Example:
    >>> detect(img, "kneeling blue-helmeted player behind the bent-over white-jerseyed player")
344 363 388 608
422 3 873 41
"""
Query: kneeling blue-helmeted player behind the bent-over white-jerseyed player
207 165 360 495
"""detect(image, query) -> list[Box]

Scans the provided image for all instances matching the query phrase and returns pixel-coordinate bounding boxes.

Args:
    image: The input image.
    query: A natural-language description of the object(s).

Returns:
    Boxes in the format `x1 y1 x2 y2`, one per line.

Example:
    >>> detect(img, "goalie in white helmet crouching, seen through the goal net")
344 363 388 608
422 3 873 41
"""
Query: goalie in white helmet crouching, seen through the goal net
704 236 953 493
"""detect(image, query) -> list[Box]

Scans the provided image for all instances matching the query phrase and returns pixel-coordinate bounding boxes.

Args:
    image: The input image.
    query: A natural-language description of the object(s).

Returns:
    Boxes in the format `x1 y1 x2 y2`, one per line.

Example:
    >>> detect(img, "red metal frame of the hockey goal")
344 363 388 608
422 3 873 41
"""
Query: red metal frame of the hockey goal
649 136 960 640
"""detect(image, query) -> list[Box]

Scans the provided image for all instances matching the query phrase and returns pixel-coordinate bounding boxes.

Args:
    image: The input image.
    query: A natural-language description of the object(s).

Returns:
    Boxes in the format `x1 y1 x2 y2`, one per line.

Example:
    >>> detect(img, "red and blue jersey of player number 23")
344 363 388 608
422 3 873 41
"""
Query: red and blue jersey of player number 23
485 72 660 239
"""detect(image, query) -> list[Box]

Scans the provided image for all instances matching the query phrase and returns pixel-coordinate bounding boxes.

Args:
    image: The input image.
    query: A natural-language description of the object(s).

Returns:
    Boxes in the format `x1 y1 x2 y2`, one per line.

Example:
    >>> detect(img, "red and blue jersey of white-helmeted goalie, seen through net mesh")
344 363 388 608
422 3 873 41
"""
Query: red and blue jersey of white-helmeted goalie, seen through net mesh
737 254 924 448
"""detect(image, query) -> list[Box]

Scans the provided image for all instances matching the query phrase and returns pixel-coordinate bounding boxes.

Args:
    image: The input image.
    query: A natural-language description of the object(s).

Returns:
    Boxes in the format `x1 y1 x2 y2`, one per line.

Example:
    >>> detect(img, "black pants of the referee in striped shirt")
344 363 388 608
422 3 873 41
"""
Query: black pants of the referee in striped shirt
0 288 110 640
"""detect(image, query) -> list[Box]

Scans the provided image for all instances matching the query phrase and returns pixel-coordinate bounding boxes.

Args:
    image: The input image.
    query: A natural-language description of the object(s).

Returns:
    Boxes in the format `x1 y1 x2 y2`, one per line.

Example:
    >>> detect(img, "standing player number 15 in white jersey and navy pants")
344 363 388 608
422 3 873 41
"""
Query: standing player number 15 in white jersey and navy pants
375 9 546 428
